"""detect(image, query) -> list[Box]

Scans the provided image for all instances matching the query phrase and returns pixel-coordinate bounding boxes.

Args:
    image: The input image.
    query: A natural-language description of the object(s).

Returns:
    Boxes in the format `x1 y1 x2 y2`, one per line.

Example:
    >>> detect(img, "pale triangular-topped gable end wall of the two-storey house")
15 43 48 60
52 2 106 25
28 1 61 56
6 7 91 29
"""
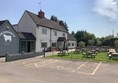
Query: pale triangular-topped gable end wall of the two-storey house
18 12 36 36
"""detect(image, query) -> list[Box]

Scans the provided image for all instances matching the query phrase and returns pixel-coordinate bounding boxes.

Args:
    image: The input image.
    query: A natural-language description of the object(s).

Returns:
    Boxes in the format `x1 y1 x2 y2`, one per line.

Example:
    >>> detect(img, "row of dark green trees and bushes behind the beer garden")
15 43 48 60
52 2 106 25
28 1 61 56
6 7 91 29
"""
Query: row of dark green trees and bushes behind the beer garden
71 31 118 47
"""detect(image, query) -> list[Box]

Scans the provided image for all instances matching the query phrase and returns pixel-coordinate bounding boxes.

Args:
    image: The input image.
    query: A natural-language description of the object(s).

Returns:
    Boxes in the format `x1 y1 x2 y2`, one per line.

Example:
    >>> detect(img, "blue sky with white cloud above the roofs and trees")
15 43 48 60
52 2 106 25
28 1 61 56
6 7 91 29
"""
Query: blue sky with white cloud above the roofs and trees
0 0 118 37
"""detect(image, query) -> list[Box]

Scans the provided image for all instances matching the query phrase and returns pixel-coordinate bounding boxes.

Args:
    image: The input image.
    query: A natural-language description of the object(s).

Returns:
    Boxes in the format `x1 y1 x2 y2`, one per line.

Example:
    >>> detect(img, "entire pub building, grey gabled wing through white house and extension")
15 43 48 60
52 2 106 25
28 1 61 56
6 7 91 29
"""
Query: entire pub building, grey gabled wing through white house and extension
0 11 76 56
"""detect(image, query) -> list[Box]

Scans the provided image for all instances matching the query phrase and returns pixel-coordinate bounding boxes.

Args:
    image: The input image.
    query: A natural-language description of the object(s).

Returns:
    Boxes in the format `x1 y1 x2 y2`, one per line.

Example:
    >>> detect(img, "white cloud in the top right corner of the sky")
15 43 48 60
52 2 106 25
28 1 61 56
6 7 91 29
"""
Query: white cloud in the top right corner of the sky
94 0 118 20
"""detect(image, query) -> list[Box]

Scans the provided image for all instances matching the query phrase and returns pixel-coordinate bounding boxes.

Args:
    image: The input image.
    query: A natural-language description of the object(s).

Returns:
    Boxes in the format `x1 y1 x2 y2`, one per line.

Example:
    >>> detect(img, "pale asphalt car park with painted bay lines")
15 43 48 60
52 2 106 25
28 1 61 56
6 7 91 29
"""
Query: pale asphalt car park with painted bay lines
0 57 118 83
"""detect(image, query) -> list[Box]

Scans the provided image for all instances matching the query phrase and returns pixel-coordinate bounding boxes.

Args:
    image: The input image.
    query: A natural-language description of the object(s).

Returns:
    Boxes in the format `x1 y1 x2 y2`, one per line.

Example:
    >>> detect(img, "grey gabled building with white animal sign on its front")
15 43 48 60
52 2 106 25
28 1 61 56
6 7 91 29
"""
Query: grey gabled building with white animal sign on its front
0 20 20 56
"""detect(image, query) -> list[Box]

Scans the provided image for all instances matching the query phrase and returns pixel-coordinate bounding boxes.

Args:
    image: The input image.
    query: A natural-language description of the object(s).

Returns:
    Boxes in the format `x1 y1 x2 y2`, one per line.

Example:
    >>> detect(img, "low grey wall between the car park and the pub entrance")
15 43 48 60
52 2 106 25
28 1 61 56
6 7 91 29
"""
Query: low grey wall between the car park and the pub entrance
5 52 44 62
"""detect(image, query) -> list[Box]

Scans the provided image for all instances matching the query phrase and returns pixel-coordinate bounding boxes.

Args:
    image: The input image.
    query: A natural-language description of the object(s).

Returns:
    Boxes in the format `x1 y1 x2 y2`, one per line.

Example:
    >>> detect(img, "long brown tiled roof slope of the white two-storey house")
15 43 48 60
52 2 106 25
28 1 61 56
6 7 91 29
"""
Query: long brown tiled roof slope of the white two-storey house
26 11 68 32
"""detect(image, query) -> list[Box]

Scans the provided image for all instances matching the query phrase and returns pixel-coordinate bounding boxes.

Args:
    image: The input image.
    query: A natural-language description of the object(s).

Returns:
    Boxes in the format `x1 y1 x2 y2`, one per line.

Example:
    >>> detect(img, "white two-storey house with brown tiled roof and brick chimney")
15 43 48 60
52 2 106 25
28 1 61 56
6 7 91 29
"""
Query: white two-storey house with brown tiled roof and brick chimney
14 11 76 52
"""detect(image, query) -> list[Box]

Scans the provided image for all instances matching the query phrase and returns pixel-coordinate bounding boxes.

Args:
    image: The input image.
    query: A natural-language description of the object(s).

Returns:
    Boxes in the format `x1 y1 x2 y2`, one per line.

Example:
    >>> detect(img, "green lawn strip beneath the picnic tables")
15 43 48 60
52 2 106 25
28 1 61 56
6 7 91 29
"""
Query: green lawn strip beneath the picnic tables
48 52 118 63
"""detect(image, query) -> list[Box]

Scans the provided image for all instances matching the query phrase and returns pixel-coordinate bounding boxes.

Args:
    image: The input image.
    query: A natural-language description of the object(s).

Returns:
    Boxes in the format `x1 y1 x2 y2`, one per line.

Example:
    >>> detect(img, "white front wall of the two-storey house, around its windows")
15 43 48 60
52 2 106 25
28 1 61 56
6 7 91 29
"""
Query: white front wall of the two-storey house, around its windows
36 26 67 52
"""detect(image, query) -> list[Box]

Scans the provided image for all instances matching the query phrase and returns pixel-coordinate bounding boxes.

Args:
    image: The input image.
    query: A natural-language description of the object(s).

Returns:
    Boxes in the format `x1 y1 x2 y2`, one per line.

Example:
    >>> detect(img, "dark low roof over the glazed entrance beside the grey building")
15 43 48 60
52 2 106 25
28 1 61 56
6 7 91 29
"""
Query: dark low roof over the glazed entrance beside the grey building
18 32 36 40
